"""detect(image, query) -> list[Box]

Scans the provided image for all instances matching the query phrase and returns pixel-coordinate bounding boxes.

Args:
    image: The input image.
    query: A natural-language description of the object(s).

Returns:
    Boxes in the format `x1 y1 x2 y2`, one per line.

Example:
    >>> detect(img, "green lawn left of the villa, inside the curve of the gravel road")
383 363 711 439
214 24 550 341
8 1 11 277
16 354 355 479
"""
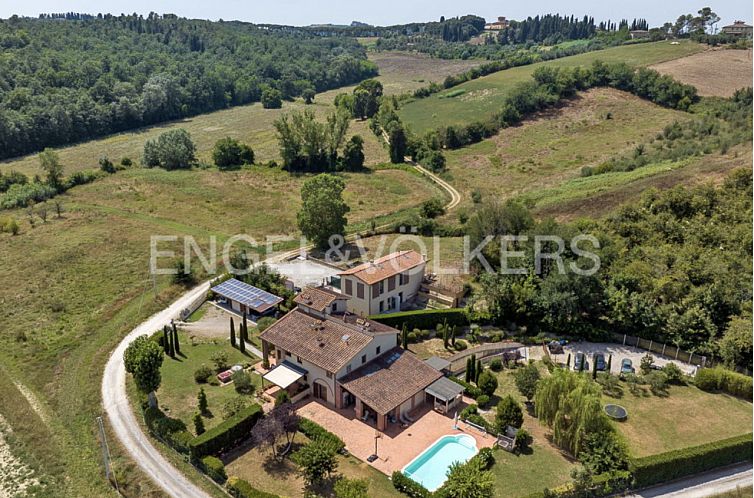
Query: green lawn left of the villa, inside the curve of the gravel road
157 332 262 432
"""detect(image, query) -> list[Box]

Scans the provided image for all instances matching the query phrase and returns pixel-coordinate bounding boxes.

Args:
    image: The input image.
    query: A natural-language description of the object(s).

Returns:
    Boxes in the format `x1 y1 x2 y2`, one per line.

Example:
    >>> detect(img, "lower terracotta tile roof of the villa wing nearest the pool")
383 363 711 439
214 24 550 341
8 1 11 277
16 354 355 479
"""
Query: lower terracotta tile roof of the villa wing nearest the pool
340 348 443 414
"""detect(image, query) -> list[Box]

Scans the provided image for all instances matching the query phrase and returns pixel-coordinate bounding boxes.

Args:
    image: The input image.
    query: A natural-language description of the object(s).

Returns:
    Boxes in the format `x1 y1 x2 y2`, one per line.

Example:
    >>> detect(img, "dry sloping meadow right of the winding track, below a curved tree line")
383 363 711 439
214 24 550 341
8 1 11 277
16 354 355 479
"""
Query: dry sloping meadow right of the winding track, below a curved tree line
438 88 688 209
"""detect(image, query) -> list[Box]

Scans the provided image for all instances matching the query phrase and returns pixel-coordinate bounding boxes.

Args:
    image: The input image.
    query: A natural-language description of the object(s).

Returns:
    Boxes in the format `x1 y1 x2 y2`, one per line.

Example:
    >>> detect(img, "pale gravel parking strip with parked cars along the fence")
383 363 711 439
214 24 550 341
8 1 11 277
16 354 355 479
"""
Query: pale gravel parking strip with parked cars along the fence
529 342 697 375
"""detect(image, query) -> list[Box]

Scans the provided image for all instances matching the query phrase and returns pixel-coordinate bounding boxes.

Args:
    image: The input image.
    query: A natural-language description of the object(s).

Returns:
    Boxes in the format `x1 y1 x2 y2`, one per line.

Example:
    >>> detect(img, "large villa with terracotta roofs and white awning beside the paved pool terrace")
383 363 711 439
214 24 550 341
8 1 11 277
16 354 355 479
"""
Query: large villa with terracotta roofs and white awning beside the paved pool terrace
260 288 463 431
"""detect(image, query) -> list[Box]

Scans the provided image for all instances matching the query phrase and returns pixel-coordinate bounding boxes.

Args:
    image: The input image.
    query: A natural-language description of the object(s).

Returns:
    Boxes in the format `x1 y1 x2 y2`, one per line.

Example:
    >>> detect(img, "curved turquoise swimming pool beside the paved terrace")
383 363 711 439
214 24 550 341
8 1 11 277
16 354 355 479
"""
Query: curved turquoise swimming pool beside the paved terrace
403 434 478 491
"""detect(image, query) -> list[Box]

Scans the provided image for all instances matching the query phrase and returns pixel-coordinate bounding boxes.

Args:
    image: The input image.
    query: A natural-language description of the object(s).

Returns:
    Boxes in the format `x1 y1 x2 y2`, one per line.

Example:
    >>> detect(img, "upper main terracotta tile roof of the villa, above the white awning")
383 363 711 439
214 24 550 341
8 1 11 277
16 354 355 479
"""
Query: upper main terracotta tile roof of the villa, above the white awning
260 309 372 372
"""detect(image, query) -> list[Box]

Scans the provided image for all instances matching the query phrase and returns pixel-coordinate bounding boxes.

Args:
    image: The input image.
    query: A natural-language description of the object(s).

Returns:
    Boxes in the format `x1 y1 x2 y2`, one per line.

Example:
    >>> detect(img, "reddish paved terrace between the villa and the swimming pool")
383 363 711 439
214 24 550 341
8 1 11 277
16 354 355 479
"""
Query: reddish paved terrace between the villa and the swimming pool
298 398 495 475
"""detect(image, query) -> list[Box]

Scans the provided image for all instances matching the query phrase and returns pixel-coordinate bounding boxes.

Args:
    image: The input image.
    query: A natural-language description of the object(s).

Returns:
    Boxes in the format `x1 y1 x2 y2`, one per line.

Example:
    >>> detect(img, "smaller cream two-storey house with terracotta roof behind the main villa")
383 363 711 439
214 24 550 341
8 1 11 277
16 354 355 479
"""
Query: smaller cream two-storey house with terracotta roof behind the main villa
338 251 426 316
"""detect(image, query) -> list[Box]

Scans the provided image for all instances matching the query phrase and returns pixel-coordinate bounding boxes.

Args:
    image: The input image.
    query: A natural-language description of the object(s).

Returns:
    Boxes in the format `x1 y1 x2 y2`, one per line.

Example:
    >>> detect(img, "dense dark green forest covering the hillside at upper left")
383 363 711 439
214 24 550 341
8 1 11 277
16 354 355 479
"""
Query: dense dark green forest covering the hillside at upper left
0 14 377 158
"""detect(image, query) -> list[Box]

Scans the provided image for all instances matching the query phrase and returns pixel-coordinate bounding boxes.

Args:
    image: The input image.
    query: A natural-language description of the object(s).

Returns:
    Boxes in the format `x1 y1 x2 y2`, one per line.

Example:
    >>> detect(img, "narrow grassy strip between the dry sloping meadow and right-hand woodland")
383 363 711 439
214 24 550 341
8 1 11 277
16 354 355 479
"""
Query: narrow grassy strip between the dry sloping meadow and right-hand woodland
521 143 751 221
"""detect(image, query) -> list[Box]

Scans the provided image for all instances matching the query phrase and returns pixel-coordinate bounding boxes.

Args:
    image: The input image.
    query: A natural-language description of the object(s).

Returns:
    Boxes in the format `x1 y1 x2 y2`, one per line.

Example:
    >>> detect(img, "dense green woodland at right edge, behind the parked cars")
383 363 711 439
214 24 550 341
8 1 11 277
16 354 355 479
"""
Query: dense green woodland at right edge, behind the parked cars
468 169 752 368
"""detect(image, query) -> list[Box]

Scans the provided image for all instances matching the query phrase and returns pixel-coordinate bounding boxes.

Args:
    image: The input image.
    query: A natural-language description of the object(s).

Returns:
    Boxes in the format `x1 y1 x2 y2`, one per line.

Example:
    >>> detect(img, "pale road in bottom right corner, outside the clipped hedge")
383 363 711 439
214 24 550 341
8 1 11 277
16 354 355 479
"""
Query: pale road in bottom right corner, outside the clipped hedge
629 462 753 498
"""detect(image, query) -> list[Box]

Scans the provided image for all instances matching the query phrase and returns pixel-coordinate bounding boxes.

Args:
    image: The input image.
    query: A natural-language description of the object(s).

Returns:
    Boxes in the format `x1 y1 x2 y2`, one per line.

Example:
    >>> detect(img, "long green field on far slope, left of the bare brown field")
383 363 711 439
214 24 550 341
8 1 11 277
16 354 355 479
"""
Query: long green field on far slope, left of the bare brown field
399 41 704 133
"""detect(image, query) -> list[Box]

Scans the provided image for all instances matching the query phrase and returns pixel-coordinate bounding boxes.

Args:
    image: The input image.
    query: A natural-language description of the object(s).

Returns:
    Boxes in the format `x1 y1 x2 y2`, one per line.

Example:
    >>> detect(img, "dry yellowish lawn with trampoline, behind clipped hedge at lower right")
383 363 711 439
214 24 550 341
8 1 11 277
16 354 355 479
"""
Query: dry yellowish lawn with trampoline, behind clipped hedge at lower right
604 386 752 456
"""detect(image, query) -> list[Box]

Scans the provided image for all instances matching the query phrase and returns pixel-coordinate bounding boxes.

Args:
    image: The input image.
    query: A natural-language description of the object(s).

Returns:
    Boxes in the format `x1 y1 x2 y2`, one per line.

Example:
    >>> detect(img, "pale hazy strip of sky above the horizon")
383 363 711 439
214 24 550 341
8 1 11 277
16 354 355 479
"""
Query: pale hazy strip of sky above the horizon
0 0 752 26
